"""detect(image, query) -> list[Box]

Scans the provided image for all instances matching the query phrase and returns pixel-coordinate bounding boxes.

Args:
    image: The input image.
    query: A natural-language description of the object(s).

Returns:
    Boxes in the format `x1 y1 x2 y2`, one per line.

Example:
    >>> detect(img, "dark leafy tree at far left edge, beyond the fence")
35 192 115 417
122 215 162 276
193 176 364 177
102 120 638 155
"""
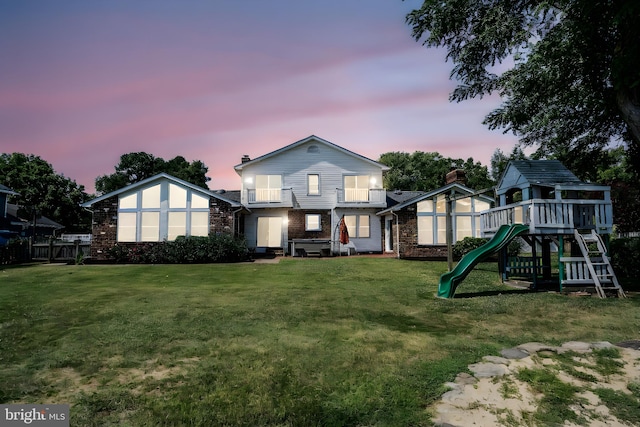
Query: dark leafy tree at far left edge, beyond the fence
0 153 91 231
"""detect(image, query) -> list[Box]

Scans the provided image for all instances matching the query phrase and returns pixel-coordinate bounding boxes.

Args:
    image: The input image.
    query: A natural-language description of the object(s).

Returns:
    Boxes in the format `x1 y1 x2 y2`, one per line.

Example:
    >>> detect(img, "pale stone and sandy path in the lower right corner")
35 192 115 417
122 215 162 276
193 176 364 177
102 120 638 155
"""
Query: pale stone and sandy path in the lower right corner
433 341 640 427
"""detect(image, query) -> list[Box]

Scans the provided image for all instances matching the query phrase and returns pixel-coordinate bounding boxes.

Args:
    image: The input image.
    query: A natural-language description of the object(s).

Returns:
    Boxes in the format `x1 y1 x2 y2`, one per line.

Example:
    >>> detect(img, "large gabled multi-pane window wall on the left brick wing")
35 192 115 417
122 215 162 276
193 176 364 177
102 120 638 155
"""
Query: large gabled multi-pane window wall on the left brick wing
117 182 209 242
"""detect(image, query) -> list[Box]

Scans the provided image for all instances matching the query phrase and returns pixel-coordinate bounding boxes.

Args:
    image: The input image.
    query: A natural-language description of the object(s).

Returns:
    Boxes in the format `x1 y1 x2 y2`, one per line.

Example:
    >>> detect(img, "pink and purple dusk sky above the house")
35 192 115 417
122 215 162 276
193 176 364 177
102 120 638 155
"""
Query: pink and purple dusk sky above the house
0 0 516 193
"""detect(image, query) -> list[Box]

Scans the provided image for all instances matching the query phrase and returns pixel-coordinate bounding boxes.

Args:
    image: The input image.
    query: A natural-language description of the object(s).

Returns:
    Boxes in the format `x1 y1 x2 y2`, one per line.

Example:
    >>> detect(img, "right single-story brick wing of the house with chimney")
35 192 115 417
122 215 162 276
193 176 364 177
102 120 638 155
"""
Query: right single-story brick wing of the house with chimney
377 169 493 259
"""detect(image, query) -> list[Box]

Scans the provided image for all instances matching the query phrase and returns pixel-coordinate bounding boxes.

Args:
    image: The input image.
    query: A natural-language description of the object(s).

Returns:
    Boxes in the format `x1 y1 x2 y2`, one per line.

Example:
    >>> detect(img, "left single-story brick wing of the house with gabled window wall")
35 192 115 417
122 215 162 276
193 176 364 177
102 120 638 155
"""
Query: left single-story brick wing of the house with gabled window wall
82 173 243 261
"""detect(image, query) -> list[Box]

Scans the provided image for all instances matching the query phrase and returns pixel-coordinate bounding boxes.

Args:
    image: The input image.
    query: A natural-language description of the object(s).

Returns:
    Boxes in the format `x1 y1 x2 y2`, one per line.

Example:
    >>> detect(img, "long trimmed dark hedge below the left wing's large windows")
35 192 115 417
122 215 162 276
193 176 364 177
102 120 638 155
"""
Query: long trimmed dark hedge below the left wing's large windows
108 234 249 264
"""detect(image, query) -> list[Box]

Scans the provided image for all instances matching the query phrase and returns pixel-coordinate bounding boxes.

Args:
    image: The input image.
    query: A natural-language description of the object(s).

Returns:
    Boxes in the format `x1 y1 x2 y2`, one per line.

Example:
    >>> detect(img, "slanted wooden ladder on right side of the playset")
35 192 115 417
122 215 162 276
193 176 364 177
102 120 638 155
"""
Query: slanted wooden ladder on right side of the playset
573 230 625 298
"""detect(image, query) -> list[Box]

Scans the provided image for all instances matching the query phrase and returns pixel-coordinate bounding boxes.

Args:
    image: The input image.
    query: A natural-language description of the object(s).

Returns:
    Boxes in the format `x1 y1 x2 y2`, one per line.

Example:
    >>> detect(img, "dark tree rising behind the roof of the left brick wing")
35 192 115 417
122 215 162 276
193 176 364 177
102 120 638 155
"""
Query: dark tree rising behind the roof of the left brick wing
95 152 209 194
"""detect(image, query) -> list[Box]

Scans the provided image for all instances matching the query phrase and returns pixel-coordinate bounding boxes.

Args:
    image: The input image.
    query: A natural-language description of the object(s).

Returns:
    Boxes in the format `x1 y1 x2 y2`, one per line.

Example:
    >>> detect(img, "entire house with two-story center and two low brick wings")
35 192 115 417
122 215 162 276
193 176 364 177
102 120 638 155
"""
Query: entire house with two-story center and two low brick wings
77 135 502 260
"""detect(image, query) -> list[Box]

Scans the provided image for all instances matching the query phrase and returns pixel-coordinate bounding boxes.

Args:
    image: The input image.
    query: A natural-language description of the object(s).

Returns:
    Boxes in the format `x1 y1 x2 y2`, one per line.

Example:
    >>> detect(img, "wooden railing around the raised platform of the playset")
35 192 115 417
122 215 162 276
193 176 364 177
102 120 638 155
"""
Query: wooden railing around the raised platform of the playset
480 199 613 235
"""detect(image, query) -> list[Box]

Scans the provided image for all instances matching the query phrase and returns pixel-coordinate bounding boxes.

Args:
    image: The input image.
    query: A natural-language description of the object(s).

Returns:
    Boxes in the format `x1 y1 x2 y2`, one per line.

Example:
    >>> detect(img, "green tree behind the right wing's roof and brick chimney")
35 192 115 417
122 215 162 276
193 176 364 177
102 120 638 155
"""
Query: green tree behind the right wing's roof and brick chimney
378 151 494 191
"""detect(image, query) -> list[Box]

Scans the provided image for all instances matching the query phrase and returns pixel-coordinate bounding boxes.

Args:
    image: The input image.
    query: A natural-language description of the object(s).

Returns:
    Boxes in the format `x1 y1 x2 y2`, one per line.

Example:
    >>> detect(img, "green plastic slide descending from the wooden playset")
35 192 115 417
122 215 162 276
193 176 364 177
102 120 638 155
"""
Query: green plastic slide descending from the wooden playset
438 224 529 298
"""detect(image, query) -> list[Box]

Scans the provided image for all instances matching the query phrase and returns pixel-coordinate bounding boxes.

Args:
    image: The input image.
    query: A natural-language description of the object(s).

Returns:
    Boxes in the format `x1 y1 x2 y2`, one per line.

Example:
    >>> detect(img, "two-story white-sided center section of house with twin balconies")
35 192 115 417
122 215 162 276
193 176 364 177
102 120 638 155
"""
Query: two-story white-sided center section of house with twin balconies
235 135 389 255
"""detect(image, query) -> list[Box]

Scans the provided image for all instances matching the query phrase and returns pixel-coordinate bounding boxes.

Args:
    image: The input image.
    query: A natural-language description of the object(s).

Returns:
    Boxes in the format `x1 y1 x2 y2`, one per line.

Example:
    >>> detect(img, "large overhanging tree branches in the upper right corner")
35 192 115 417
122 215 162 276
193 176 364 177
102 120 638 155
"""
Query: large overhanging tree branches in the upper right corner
407 0 640 174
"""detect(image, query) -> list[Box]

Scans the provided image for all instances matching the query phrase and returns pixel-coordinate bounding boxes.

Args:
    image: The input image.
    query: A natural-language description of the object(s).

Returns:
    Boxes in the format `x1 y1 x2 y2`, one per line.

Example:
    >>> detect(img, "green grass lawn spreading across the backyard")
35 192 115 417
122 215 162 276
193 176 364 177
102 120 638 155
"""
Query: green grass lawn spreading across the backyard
0 256 640 426
